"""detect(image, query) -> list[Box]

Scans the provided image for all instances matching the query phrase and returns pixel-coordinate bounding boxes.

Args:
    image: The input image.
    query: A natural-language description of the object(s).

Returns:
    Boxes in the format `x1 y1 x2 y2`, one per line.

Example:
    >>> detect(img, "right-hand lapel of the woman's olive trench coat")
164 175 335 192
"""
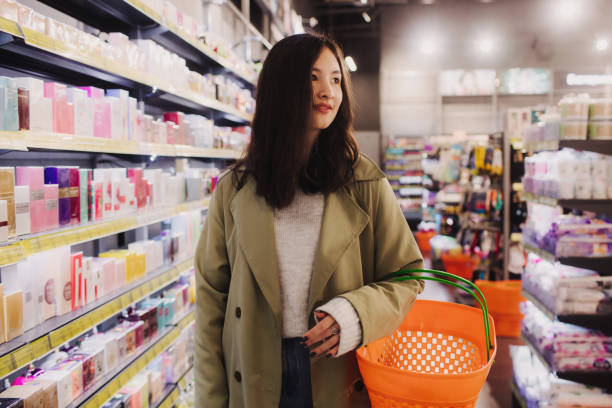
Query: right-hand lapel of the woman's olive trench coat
308 188 370 310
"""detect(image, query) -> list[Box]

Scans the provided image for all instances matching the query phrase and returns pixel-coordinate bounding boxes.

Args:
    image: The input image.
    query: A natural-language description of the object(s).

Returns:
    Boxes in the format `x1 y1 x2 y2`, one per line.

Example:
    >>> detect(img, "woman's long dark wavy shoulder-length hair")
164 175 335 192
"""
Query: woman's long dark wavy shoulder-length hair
233 34 359 209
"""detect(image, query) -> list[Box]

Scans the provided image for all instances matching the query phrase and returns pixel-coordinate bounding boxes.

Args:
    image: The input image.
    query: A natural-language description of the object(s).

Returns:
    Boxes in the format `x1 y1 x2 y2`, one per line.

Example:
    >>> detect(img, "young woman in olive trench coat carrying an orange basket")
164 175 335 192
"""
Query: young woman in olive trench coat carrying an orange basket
195 34 423 408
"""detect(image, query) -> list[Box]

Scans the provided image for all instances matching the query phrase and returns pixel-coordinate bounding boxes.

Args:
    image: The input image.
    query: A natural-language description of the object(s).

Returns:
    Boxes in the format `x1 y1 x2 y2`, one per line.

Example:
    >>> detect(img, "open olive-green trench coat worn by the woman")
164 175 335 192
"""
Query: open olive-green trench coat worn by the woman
195 155 423 408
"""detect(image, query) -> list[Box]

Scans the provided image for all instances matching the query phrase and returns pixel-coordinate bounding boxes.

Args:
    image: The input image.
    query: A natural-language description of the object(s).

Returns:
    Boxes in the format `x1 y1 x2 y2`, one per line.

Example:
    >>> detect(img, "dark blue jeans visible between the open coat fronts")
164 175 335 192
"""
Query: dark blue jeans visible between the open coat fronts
279 338 312 408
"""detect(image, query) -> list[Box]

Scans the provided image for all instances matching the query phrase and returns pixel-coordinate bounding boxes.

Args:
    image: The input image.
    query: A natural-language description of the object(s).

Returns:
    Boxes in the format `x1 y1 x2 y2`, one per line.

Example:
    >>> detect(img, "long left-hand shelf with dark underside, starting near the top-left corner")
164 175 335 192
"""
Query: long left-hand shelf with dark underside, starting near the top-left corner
0 17 252 123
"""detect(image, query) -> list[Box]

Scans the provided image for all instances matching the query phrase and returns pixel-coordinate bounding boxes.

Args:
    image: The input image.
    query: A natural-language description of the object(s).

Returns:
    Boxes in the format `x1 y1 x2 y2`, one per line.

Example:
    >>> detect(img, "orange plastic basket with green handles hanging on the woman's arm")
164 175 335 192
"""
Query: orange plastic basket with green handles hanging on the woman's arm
357 269 497 408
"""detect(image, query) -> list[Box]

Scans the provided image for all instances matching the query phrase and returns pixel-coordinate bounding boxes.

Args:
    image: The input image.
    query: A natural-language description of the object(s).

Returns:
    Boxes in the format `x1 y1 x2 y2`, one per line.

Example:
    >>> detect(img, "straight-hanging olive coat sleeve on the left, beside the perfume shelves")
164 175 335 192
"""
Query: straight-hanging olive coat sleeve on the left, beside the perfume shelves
194 182 230 408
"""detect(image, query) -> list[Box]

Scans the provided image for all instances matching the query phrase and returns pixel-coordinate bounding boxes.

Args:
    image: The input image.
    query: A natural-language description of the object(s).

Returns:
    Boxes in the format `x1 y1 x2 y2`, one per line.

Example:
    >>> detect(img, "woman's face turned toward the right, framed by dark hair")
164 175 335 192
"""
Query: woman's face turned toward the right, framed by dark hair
310 47 342 136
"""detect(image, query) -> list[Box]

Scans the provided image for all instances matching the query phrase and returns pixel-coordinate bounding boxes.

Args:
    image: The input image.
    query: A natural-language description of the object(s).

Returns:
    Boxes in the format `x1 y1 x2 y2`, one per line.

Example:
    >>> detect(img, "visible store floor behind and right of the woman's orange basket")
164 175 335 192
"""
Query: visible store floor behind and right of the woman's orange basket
419 274 521 408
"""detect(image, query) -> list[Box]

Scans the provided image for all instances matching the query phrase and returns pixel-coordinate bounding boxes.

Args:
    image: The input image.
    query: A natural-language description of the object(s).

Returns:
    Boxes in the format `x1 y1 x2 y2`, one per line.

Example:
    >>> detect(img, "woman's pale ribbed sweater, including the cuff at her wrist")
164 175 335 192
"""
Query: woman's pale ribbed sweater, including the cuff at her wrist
274 191 361 356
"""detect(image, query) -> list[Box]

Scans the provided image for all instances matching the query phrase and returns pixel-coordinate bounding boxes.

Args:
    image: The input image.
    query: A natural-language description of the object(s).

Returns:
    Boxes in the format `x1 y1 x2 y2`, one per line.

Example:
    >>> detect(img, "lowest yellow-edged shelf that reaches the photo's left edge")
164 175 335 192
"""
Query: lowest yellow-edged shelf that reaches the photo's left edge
0 257 194 378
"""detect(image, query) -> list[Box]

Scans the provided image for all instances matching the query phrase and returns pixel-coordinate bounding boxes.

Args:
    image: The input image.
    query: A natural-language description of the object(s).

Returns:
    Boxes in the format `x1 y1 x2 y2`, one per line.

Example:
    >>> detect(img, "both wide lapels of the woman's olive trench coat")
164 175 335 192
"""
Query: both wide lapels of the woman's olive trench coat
230 179 369 323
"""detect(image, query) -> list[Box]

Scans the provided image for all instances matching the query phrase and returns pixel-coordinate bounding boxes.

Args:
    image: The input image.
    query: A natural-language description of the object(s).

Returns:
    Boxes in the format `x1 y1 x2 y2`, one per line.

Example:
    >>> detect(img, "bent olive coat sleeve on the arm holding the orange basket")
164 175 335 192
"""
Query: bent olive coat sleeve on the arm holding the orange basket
341 179 424 344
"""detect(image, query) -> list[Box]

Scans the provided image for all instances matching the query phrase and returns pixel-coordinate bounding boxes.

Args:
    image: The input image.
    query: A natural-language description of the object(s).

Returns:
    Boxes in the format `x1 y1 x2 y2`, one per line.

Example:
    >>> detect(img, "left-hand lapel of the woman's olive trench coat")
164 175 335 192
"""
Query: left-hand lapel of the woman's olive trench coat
230 180 281 324
